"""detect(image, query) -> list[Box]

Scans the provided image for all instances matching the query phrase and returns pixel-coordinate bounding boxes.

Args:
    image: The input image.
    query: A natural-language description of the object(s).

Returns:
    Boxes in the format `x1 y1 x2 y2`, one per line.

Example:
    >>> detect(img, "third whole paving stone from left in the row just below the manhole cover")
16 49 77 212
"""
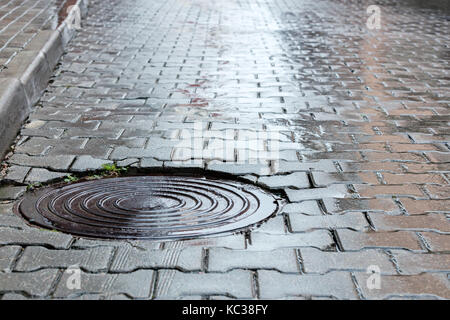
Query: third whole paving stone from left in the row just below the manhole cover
208 248 299 273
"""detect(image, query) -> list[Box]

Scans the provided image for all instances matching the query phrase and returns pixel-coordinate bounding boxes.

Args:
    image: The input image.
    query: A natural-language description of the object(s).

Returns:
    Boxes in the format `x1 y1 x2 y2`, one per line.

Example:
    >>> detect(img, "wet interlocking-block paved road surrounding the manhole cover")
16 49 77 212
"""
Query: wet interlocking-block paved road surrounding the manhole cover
0 0 450 299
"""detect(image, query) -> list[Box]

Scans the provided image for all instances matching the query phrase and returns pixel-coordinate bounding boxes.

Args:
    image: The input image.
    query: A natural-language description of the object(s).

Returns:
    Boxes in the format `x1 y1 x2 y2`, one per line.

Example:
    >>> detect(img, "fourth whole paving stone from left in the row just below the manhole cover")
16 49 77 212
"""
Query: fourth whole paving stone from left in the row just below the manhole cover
300 248 396 274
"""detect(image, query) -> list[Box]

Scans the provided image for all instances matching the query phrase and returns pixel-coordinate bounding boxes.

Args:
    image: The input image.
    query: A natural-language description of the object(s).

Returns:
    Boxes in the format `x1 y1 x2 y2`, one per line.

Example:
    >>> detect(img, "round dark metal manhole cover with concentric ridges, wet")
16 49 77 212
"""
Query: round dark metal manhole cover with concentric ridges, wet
15 175 280 240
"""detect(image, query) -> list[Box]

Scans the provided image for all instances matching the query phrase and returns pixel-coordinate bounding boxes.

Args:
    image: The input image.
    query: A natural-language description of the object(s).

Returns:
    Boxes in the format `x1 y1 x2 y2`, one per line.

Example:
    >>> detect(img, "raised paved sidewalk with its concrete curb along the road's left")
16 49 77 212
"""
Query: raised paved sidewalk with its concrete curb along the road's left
0 0 88 159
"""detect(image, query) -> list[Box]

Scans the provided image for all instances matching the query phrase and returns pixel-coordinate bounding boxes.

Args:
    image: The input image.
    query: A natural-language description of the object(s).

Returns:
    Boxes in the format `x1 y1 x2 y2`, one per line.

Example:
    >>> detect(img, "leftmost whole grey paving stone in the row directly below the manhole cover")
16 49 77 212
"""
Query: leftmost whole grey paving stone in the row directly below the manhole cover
15 247 113 272
